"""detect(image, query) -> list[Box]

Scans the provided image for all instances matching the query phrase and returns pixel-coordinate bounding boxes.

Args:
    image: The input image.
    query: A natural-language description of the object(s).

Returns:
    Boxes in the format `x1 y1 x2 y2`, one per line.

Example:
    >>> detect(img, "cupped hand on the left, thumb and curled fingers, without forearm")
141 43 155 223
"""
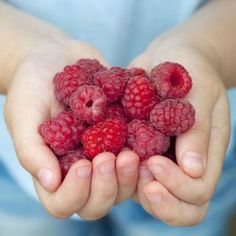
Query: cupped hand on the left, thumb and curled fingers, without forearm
5 37 138 219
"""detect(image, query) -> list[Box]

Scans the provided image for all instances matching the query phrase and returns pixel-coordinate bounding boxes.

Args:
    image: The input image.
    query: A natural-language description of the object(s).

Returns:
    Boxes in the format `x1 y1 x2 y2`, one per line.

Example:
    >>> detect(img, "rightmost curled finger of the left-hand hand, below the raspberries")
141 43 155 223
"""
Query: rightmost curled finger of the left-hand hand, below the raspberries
116 150 139 204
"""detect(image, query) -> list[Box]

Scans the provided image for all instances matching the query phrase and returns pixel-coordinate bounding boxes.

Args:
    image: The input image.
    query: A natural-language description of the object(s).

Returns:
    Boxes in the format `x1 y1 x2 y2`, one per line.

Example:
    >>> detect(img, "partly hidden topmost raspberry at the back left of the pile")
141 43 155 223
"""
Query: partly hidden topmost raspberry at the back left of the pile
76 59 106 77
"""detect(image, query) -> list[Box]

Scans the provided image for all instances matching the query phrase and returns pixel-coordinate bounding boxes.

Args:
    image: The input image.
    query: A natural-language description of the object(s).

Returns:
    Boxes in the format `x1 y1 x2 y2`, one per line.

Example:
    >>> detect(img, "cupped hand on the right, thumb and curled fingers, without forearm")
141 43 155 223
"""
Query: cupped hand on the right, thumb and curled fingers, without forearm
131 41 229 226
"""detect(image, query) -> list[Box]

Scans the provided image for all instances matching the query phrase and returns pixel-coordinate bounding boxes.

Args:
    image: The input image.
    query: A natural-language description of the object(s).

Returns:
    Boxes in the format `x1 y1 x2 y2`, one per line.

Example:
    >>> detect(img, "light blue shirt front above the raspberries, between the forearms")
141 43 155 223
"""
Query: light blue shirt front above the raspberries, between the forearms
8 0 204 66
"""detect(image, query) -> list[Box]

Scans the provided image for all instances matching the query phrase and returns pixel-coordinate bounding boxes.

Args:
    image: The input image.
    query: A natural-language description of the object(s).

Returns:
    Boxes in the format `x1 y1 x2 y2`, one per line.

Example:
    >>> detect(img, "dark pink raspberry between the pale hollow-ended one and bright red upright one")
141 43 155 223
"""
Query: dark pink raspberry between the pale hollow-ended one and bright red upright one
94 67 130 102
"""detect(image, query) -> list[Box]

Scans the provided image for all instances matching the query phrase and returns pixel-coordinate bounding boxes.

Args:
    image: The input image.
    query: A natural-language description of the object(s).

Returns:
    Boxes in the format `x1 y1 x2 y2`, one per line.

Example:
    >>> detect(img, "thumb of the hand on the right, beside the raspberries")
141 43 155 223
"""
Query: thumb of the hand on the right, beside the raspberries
176 78 218 178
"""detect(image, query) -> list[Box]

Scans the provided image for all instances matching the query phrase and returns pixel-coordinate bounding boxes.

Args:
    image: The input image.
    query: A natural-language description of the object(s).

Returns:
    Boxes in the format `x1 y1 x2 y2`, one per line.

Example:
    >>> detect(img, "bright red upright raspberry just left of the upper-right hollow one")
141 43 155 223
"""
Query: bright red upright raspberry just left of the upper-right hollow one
121 76 159 120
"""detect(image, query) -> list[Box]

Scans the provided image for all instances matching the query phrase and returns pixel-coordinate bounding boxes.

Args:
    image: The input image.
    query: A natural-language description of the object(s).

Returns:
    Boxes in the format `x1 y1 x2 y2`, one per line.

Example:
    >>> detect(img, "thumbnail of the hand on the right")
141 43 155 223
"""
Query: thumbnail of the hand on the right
182 151 204 171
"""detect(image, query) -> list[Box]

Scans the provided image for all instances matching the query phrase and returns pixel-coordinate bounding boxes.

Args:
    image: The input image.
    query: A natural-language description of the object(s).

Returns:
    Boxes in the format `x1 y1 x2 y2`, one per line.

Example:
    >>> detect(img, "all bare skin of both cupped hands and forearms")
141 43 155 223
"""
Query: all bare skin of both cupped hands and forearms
0 0 236 226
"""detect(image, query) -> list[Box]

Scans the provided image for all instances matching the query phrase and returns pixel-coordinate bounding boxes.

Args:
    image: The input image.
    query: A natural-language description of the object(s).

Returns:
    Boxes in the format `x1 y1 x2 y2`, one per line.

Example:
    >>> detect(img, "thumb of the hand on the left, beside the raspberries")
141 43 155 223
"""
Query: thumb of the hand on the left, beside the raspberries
5 94 61 192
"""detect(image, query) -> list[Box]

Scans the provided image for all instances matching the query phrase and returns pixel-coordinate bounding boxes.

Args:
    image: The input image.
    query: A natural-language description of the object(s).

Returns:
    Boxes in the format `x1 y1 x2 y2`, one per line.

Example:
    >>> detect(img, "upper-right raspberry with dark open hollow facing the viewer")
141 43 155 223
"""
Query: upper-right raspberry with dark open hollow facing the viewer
150 62 192 98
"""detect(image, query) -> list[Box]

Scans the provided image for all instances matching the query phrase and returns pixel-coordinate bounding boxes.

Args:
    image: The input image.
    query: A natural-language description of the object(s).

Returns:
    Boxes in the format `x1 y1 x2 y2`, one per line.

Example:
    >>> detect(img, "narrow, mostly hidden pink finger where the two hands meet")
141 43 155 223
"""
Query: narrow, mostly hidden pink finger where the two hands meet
137 161 154 213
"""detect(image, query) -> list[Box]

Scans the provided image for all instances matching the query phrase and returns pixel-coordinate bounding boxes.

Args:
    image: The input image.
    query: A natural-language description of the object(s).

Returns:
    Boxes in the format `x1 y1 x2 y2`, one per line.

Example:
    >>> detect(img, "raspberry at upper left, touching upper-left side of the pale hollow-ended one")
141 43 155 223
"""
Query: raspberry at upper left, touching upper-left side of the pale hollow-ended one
53 65 90 105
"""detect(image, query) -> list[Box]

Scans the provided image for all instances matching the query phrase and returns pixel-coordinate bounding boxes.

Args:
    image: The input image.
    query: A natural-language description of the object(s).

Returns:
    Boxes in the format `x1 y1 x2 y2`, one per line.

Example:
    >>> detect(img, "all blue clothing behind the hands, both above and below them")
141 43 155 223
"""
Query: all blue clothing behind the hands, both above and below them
0 0 236 236
